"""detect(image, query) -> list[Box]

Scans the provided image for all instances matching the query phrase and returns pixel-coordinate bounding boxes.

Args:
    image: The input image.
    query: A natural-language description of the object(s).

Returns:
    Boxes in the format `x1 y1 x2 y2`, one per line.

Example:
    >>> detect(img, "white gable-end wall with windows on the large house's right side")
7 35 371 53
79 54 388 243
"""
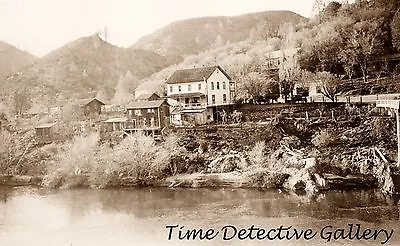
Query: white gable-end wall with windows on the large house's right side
207 69 232 106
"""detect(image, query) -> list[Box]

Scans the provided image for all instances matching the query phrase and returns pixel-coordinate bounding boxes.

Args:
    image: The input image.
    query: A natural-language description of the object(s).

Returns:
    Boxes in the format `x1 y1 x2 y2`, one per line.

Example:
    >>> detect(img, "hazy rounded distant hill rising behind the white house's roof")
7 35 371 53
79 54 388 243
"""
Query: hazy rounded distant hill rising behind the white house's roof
132 11 306 57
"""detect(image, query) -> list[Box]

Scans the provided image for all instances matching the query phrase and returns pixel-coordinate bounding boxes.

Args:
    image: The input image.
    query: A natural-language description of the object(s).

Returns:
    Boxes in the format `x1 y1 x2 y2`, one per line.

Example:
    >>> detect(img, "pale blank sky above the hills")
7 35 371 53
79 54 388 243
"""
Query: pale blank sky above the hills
0 0 314 56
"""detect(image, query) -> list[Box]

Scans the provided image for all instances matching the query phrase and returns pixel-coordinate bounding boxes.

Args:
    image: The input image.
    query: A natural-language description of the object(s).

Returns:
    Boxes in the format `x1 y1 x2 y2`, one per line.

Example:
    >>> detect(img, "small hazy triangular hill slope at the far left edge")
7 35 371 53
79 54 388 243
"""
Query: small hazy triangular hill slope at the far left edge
0 41 37 78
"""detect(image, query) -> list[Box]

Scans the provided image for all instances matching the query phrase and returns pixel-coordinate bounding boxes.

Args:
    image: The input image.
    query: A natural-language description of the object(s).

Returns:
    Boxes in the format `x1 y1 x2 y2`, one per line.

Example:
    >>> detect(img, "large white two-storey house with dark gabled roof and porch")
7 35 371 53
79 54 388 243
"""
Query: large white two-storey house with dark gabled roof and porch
166 66 234 125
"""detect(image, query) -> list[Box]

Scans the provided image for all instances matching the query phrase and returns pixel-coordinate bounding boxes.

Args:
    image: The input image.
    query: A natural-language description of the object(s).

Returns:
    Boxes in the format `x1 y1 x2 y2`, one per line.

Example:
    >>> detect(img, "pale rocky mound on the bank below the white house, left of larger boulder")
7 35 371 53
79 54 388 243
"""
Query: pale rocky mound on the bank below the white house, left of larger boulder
208 154 249 173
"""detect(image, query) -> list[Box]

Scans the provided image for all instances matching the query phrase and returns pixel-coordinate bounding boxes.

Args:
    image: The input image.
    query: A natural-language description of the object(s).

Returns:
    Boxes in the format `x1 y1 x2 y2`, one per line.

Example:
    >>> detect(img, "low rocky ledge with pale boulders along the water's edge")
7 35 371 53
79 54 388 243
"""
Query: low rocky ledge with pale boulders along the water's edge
165 151 379 192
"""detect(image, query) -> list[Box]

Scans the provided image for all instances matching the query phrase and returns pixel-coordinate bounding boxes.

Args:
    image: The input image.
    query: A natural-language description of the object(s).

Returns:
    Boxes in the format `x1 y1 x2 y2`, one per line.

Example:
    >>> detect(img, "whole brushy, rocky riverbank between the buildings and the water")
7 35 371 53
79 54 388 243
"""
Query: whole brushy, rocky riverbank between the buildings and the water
0 107 398 194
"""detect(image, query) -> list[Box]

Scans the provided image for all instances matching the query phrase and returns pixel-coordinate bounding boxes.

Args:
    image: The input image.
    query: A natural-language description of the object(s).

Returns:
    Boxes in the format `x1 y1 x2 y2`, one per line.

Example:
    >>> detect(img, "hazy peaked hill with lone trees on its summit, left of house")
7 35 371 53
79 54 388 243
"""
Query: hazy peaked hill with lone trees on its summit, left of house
1 35 173 112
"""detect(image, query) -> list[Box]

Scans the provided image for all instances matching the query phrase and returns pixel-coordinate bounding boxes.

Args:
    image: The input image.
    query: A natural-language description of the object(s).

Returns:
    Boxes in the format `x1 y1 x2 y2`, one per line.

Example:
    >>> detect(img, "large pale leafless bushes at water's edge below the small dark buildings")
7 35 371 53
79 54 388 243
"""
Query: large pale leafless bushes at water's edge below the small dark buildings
44 133 182 188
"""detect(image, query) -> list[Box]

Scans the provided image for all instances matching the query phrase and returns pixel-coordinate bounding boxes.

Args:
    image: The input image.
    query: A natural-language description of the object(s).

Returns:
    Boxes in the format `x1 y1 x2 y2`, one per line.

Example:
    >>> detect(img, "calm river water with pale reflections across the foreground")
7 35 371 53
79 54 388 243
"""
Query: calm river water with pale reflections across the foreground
0 187 400 246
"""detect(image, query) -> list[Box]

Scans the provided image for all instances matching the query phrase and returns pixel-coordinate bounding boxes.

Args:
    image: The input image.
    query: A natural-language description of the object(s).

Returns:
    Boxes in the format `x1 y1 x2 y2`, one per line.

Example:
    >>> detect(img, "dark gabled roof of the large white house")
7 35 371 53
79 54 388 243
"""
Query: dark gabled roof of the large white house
167 66 231 84
